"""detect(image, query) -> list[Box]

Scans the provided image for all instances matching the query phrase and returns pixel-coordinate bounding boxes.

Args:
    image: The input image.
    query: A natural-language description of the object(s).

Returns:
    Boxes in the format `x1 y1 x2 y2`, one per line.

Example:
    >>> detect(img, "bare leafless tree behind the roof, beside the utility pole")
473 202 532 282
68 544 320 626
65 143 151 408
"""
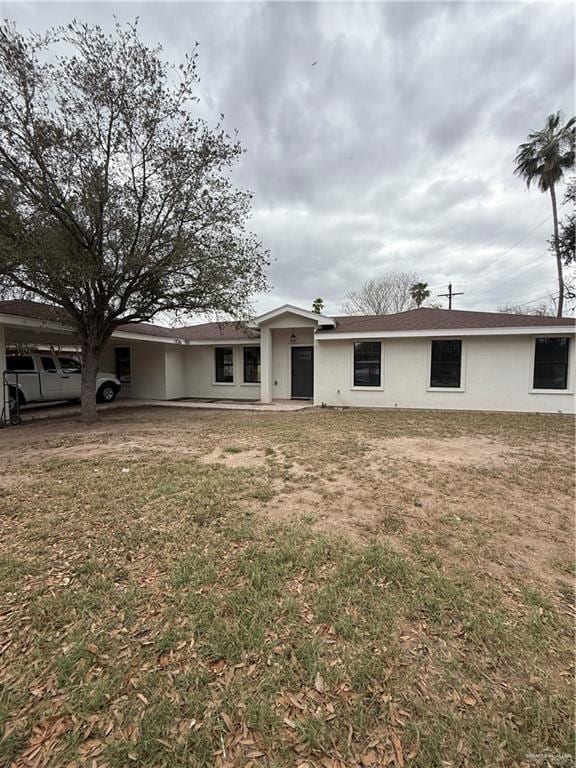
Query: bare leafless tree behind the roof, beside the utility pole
341 272 421 315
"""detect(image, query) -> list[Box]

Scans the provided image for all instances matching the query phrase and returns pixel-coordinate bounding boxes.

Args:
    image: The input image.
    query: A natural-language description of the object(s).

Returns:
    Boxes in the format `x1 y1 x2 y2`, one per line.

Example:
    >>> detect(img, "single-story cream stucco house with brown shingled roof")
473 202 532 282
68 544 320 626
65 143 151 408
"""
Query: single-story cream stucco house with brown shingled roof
0 300 576 413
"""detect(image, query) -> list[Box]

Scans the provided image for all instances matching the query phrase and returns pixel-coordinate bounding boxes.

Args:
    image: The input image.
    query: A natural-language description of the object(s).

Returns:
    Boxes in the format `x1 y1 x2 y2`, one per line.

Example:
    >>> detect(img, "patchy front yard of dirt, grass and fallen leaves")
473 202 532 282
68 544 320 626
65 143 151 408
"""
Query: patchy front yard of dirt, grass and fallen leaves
0 409 574 768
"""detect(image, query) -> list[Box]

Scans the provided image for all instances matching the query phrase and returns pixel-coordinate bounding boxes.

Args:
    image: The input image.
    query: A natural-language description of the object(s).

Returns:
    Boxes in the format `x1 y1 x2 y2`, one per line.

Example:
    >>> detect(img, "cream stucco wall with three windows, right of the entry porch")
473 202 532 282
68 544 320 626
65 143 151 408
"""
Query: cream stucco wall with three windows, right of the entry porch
315 334 576 413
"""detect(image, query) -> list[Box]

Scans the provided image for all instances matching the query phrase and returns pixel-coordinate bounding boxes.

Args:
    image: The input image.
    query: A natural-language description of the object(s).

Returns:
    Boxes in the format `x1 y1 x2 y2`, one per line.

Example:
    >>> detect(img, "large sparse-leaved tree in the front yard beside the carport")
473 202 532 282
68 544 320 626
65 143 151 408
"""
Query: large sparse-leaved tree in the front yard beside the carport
0 22 267 420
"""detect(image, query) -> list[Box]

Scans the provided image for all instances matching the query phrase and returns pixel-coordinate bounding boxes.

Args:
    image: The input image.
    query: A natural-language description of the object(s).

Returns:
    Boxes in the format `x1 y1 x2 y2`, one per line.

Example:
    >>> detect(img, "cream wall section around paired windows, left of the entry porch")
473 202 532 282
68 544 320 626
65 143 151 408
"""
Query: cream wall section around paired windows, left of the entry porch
184 343 260 400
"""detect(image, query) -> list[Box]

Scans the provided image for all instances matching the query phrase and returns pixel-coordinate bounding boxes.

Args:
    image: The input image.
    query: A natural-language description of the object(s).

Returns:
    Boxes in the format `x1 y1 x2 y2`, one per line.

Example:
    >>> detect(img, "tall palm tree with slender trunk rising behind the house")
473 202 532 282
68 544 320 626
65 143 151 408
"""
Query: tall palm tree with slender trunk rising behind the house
514 112 576 317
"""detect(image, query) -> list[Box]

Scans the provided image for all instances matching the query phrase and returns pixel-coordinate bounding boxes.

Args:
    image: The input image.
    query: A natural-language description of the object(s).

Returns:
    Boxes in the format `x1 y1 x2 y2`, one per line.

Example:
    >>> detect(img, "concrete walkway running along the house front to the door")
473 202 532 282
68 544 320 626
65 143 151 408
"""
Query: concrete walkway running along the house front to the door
20 398 313 422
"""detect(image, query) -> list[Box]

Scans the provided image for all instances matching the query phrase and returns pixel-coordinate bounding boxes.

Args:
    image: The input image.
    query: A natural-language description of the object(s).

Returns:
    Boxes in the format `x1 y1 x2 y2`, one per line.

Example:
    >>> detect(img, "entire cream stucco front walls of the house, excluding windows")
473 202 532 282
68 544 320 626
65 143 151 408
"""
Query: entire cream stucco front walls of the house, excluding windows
97 325 576 413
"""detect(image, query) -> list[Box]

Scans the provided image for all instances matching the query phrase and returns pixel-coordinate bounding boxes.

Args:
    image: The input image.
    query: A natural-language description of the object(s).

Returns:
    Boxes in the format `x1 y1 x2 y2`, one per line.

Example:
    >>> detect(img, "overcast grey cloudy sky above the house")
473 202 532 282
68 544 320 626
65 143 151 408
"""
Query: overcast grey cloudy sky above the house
0 2 575 312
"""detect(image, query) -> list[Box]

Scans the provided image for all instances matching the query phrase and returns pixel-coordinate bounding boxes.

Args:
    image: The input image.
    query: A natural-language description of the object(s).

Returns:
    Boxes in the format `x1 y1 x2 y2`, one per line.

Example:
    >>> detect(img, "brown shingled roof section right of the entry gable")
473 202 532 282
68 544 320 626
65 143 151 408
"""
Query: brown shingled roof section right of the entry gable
318 307 576 335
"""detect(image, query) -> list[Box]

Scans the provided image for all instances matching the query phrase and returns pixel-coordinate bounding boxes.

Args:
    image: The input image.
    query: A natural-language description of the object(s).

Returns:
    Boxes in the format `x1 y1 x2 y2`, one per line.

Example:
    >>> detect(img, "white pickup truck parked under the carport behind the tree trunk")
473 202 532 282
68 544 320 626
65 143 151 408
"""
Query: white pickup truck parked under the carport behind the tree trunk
6 352 120 410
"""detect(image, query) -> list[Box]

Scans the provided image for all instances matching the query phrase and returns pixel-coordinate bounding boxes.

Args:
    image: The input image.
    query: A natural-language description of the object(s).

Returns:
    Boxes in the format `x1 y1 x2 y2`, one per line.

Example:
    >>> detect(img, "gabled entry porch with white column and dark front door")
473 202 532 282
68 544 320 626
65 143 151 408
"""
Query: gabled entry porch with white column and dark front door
254 304 334 403
